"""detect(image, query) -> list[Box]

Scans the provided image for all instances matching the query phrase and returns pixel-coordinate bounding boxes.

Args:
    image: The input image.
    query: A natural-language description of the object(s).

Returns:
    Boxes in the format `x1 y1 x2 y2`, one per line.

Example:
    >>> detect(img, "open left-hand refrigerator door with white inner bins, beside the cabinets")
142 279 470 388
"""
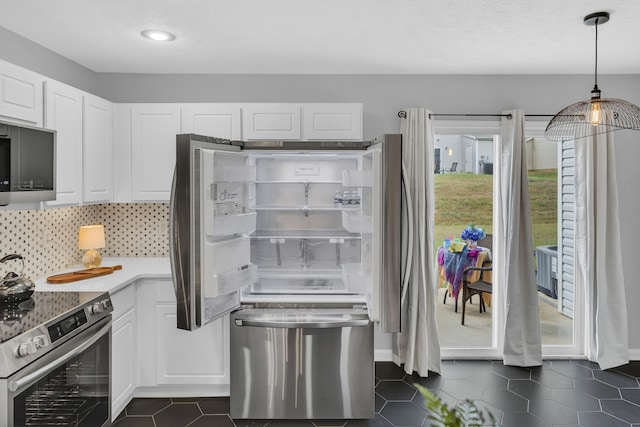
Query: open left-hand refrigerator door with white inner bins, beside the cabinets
169 135 257 330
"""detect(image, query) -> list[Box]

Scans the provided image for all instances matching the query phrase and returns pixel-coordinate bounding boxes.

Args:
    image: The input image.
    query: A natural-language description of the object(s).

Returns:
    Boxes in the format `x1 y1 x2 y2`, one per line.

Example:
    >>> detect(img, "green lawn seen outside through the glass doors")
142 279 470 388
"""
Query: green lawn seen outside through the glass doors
434 170 558 250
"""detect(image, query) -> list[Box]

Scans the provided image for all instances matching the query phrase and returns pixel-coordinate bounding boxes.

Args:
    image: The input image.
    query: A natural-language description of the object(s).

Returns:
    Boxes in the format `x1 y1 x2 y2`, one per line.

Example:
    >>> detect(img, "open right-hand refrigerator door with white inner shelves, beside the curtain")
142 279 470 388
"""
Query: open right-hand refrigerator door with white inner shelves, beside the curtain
342 135 402 332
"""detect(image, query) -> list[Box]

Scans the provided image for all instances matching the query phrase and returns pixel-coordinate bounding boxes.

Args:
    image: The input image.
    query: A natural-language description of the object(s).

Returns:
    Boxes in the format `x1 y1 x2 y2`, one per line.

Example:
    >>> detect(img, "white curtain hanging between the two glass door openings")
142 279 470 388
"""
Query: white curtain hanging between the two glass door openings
493 109 542 366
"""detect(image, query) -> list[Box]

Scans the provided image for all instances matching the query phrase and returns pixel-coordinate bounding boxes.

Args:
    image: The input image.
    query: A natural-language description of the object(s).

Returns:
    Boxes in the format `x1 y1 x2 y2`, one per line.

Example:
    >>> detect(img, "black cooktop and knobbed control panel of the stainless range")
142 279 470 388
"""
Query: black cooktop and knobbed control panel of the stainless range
0 291 113 378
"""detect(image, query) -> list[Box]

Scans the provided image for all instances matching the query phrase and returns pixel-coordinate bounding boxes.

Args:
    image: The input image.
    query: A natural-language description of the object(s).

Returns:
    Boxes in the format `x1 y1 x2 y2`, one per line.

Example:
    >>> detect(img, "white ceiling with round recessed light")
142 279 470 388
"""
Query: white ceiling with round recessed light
0 0 640 74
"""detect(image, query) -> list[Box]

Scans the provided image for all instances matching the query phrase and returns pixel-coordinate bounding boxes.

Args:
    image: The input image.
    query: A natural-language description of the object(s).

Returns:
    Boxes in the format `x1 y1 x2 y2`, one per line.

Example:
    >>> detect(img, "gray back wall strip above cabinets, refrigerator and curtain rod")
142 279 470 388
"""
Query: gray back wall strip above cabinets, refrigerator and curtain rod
96 74 640 139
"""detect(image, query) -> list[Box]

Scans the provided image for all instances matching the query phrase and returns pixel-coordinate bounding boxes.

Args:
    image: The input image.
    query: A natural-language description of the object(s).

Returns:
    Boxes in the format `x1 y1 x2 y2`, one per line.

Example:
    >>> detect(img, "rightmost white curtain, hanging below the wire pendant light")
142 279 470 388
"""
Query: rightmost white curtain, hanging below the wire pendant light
574 133 629 369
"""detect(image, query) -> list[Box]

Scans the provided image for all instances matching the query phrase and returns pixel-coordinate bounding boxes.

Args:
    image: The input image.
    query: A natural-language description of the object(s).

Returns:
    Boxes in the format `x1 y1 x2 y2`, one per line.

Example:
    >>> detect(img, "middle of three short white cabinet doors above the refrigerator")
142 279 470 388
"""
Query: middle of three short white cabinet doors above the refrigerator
242 104 301 140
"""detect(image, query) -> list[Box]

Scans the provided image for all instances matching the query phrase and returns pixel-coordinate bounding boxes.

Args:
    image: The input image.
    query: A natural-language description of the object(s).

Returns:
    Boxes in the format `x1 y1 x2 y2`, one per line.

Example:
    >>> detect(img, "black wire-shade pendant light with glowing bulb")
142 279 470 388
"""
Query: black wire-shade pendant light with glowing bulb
544 12 640 141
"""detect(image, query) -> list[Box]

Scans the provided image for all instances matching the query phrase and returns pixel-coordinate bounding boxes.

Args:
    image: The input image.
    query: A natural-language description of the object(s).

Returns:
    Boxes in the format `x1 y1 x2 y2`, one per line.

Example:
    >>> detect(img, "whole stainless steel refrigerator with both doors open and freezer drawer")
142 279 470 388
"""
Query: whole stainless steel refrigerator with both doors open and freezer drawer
170 134 406 419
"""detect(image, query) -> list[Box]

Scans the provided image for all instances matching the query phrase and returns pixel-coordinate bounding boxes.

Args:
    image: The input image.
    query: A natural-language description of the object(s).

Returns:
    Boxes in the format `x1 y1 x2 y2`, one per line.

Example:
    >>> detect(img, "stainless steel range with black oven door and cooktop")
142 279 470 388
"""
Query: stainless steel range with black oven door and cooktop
0 292 113 427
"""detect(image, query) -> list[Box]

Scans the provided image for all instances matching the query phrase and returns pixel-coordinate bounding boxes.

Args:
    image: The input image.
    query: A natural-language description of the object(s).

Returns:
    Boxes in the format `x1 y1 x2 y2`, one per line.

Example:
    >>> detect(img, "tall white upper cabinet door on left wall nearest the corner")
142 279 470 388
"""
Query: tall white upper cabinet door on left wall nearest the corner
83 94 113 202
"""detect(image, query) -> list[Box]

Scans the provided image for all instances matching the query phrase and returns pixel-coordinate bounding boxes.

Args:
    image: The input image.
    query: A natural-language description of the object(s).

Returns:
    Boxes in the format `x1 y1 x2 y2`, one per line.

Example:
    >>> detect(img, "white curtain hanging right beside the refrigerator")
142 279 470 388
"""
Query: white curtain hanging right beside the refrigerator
393 108 440 377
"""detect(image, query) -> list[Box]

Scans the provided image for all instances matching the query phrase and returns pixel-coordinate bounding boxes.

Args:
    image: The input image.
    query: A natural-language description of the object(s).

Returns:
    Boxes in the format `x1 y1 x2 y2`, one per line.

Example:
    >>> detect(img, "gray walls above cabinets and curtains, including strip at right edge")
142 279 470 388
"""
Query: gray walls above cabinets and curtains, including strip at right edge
0 27 640 355
